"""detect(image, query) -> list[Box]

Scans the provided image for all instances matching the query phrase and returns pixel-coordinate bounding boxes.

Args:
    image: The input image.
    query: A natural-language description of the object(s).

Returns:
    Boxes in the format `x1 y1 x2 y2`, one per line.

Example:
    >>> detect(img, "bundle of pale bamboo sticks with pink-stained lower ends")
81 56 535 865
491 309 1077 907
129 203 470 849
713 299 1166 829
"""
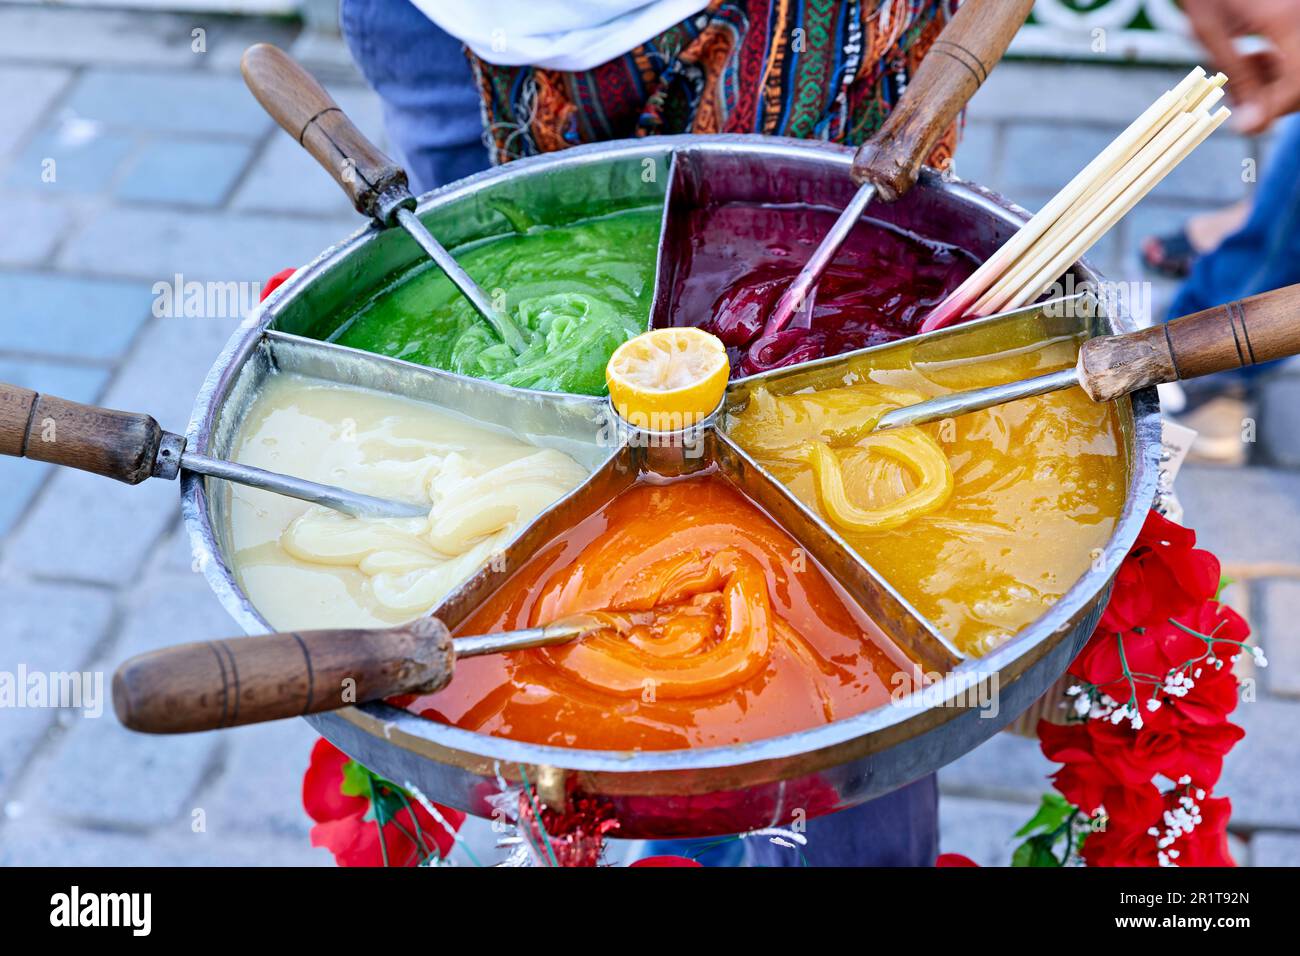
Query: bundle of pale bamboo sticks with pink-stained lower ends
920 66 1229 332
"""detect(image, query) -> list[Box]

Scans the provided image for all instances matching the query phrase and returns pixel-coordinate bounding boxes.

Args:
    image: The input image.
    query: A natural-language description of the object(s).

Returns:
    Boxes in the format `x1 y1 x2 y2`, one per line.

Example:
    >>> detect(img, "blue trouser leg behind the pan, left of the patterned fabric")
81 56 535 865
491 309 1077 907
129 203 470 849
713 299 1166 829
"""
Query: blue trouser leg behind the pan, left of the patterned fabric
339 0 489 193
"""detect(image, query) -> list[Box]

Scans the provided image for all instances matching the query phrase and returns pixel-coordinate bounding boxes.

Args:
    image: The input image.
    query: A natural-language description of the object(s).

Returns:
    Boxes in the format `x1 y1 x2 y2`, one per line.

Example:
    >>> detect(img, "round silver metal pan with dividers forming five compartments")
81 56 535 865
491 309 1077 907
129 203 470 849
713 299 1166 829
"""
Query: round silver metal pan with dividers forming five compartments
182 137 1160 836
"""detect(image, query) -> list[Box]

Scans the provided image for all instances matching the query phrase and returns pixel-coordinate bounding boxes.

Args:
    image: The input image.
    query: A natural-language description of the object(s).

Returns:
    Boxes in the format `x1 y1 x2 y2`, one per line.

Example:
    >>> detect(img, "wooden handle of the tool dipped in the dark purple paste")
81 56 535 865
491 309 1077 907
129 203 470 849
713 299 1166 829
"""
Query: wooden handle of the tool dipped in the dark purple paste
853 0 1034 203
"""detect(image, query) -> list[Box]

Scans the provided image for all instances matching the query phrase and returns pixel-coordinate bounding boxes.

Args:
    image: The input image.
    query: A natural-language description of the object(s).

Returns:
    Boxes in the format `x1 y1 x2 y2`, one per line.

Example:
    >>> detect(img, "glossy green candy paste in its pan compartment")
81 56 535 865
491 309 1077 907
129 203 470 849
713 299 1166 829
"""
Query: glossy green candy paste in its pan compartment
333 207 662 395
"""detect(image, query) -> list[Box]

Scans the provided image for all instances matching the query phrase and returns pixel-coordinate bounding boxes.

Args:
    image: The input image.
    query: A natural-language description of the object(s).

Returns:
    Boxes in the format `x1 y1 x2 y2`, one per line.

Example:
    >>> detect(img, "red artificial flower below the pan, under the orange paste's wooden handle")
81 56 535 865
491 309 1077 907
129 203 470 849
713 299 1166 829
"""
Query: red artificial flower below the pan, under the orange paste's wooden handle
303 737 465 866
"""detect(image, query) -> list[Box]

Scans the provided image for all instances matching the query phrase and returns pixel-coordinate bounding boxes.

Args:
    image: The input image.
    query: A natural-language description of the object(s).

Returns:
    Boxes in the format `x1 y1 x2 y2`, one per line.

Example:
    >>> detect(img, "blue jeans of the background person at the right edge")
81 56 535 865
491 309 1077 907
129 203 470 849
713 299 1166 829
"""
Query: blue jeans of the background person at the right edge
1169 113 1300 377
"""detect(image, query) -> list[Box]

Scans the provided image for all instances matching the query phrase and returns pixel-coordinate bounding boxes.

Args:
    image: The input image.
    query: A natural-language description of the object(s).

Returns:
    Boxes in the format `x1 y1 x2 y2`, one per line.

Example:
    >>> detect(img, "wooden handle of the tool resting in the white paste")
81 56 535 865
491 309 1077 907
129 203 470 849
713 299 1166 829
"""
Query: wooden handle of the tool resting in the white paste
0 382 167 485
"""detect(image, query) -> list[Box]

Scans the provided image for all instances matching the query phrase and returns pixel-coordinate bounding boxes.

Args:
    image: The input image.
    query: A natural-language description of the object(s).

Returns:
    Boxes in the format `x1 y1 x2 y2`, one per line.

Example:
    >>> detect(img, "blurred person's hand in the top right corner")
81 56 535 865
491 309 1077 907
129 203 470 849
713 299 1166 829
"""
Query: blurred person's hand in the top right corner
1183 0 1300 133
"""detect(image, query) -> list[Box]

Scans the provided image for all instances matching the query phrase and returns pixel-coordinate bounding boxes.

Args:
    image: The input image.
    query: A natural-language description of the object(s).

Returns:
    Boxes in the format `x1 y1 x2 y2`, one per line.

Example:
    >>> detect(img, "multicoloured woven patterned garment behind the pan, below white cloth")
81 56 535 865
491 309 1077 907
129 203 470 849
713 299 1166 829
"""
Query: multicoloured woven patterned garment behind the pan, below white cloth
468 0 958 168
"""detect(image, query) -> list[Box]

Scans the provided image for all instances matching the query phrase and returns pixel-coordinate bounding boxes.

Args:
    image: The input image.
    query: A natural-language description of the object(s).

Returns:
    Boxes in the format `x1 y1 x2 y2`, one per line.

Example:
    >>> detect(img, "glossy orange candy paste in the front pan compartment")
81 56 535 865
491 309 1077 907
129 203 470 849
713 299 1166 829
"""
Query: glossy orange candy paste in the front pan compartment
407 476 918 750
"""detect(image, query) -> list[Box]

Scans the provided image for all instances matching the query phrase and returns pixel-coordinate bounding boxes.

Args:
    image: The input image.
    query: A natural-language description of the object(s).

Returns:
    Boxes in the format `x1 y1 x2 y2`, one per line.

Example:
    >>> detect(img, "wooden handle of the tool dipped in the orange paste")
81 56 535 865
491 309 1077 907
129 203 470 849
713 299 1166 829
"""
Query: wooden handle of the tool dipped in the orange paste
113 618 455 734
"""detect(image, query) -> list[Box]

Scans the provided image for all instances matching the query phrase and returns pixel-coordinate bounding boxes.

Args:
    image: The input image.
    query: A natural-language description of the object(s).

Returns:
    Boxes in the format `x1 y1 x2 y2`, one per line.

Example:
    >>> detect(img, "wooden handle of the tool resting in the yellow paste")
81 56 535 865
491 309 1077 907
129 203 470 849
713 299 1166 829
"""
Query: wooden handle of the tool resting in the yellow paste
1079 285 1300 402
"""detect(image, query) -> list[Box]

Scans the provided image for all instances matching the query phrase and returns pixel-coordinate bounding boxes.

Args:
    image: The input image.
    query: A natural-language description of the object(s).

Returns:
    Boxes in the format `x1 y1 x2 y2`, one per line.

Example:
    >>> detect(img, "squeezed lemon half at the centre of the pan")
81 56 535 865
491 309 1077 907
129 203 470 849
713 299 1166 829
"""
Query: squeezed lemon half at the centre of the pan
605 328 731 432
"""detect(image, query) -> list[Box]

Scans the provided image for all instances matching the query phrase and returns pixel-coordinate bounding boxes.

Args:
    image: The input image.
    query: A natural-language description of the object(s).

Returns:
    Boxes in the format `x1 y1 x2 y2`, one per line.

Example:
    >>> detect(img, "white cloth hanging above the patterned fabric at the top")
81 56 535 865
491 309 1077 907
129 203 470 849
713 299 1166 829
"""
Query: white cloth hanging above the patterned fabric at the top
411 0 709 72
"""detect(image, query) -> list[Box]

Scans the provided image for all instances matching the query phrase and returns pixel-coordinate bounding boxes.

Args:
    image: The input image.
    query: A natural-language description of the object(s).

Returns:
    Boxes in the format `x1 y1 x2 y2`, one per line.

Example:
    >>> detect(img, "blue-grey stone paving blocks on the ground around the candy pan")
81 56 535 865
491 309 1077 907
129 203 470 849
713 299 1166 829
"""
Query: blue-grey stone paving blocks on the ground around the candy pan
0 5 1300 864
